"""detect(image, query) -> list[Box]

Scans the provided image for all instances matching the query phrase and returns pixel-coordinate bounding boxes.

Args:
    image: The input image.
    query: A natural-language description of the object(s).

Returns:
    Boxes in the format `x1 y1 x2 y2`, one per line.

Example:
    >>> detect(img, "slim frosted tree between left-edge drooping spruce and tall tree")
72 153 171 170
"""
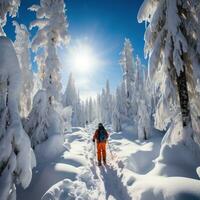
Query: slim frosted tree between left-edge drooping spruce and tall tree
13 21 34 118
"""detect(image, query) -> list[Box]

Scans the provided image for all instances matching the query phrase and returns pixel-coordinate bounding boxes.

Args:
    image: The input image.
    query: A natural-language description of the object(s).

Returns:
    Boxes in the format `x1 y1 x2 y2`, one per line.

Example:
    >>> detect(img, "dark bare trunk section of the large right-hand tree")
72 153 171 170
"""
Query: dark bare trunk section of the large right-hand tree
176 67 191 127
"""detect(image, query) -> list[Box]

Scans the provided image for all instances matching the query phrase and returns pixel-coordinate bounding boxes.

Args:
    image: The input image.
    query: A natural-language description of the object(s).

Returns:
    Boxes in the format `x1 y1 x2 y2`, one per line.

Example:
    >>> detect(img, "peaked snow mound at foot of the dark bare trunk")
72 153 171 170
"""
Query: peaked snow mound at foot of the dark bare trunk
150 121 200 179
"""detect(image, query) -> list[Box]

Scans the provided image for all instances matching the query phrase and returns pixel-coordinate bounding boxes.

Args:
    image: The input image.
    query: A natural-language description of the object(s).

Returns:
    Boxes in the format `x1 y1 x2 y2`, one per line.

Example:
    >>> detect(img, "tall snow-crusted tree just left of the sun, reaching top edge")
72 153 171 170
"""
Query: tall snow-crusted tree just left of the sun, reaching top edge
25 0 68 149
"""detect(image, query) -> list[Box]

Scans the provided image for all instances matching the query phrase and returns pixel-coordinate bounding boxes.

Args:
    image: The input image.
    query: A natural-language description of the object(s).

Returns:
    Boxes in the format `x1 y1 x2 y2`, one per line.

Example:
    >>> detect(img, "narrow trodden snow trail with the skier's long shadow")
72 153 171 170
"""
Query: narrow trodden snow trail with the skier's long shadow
86 127 131 200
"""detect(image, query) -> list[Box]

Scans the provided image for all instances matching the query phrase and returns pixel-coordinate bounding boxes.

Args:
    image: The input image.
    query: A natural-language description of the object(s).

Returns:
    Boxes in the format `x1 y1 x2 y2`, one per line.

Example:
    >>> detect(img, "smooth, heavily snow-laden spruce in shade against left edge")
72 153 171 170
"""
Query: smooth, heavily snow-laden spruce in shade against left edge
0 36 36 200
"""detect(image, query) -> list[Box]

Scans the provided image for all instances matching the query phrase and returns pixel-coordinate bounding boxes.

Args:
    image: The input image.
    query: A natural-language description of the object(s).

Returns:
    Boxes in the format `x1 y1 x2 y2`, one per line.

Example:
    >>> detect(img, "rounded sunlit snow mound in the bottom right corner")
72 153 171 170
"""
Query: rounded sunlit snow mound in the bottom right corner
132 177 200 200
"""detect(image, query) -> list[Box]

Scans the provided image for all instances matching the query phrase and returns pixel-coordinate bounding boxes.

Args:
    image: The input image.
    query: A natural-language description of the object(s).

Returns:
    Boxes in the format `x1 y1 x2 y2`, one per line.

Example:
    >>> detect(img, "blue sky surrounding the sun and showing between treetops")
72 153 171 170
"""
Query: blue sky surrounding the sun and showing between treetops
4 0 146 98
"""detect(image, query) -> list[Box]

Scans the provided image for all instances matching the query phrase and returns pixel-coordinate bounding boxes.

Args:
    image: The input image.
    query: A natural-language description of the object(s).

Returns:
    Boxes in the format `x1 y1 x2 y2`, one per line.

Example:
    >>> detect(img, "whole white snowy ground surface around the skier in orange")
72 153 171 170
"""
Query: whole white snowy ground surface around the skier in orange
18 125 200 200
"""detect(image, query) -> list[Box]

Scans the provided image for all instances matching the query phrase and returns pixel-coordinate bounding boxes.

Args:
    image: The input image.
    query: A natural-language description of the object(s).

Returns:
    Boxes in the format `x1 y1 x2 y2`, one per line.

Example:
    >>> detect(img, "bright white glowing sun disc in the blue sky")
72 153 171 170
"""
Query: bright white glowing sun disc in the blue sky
70 43 97 73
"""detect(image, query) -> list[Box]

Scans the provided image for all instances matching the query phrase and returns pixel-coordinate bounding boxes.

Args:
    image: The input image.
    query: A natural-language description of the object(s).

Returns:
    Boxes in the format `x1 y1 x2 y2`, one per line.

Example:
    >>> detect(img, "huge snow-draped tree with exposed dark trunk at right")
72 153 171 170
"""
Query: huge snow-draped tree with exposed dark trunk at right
138 0 200 143
